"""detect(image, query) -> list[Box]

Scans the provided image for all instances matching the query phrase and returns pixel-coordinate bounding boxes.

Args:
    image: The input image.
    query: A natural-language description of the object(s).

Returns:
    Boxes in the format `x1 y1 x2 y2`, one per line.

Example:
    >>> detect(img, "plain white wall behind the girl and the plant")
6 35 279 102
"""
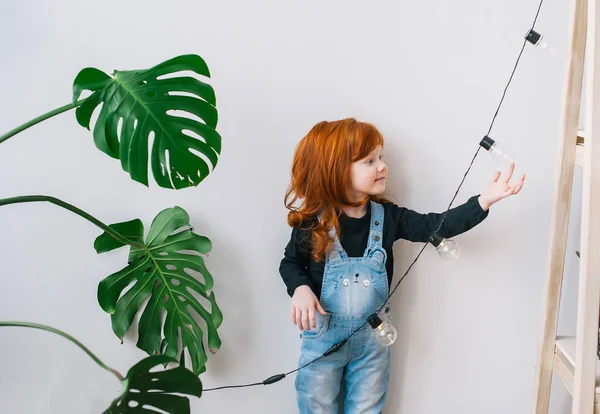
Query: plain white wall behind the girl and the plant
0 0 580 414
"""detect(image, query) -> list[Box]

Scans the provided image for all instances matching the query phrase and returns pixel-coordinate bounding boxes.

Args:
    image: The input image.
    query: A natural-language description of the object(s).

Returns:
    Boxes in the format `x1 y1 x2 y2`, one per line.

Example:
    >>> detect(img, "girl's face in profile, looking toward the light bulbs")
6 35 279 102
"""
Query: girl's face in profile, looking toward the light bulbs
347 146 387 201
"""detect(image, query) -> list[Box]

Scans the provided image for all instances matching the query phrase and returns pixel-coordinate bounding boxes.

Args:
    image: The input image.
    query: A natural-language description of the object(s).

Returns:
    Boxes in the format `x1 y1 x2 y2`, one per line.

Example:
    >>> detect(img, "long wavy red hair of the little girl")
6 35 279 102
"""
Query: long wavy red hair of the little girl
284 118 385 261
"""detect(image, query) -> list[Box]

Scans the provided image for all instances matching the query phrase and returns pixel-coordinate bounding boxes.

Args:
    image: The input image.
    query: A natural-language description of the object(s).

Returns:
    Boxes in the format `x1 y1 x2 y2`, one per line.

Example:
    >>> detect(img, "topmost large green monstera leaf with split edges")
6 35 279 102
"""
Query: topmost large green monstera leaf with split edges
73 55 221 189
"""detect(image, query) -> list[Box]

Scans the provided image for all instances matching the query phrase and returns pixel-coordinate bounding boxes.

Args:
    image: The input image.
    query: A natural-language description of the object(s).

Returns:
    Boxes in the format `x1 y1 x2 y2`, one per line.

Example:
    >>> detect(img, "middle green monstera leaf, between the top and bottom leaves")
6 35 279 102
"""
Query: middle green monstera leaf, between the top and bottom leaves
94 207 223 374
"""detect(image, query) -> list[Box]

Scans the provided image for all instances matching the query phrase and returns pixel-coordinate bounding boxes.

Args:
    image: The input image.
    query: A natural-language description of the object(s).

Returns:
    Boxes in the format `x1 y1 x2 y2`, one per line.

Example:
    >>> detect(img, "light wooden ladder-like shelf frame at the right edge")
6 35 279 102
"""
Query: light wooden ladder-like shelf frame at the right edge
534 0 600 414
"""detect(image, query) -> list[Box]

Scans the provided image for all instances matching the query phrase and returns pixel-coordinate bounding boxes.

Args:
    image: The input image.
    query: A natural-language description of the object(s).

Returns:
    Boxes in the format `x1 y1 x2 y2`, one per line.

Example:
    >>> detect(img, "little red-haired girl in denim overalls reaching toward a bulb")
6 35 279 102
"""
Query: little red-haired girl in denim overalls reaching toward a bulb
279 118 525 414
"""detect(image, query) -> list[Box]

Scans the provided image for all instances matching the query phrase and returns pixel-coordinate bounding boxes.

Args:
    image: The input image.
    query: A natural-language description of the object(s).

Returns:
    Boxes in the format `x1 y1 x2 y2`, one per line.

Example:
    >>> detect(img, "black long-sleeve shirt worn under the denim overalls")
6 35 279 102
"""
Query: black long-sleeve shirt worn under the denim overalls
279 196 489 297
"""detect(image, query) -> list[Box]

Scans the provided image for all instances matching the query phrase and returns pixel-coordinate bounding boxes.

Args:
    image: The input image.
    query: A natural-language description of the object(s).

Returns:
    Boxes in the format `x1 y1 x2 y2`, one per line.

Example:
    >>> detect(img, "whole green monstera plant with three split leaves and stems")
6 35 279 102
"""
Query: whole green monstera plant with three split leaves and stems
0 55 223 414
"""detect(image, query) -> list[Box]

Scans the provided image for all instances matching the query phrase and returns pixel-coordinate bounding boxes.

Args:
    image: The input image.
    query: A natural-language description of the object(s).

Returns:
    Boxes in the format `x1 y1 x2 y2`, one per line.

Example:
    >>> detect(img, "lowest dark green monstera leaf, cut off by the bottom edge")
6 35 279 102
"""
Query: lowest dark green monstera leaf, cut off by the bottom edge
104 355 202 414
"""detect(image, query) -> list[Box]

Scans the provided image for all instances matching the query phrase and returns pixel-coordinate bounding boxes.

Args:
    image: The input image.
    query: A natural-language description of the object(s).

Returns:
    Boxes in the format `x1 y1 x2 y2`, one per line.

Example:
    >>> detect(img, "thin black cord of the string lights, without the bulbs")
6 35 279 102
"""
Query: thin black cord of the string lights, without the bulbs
203 0 548 392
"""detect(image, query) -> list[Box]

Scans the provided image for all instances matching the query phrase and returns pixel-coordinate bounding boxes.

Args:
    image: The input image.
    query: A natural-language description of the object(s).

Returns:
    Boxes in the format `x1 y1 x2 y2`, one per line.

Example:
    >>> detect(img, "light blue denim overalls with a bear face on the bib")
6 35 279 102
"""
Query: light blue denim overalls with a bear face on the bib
296 201 390 414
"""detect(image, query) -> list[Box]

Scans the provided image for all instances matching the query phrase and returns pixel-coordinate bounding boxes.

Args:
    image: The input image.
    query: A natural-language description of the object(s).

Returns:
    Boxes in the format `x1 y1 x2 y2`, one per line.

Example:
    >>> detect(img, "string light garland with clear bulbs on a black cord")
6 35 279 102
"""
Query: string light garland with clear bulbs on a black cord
203 0 548 392
